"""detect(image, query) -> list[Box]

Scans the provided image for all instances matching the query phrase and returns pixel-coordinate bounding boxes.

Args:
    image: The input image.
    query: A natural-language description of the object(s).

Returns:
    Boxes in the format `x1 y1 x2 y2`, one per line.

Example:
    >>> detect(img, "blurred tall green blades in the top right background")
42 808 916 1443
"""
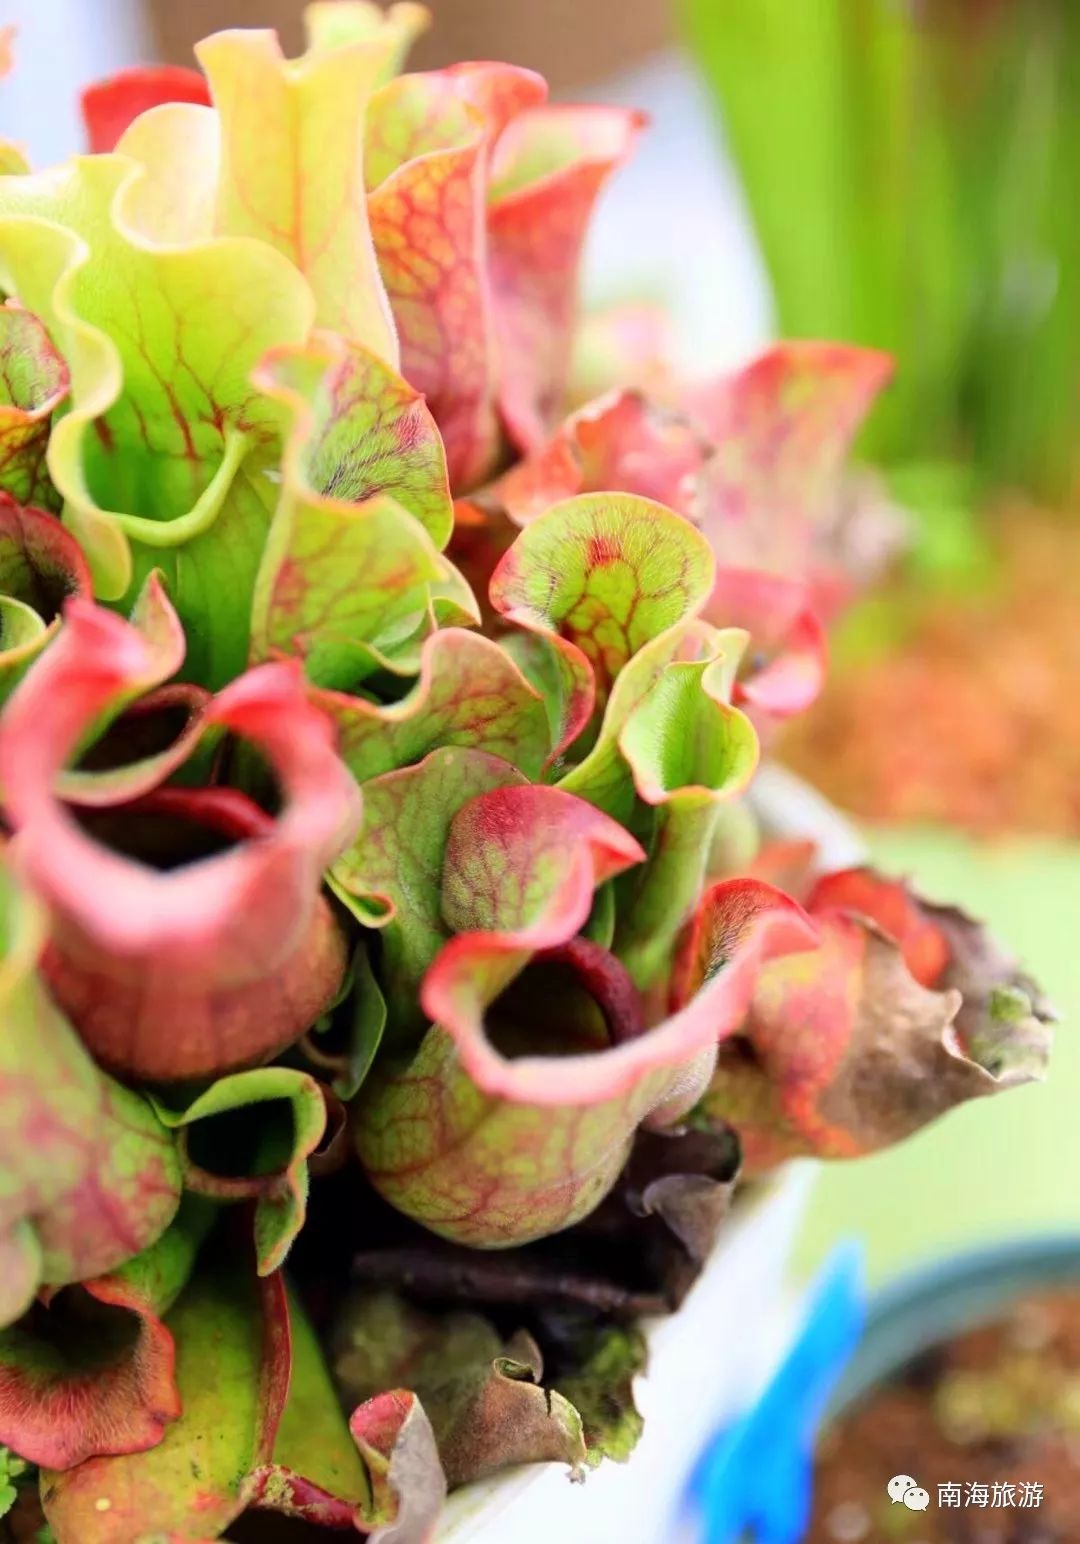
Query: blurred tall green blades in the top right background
683 0 1080 517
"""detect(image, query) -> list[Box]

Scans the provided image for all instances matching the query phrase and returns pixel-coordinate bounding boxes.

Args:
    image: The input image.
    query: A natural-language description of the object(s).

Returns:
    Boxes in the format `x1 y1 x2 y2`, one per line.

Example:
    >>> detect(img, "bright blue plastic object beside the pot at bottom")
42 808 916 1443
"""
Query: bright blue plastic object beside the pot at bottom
681 1244 867 1544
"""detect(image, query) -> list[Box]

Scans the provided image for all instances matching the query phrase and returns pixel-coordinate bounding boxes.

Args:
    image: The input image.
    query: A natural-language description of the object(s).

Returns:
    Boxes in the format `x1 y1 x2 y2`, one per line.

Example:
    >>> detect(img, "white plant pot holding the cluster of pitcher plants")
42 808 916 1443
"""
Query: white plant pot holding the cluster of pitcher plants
436 766 865 1544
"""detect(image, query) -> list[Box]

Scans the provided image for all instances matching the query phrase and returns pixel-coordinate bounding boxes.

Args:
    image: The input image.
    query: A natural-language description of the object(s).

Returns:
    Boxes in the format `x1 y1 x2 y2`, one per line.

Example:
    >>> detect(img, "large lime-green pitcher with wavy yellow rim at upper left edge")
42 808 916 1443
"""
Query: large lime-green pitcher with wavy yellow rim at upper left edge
0 156 314 684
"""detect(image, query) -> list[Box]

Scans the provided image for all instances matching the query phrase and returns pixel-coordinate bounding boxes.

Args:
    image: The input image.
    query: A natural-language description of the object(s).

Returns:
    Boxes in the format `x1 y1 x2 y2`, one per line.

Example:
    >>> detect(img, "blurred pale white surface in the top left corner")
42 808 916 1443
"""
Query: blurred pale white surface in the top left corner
0 0 153 167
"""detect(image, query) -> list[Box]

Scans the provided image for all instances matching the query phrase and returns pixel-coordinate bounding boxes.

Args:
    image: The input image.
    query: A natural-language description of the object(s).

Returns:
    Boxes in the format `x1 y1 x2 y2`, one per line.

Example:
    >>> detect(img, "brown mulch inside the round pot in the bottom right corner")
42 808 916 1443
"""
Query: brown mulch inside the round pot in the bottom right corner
805 1291 1080 1544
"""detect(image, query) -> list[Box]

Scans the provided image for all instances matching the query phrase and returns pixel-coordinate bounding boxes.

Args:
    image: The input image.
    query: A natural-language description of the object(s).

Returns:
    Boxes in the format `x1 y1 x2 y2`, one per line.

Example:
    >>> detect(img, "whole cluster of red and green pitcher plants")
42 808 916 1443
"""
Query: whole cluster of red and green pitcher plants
0 0 1049 1544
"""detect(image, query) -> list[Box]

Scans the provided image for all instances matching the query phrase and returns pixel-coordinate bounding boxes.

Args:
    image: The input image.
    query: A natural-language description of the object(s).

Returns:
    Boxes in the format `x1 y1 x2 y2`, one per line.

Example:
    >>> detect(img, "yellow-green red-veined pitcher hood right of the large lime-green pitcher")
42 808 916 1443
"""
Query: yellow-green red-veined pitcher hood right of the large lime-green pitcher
252 338 463 687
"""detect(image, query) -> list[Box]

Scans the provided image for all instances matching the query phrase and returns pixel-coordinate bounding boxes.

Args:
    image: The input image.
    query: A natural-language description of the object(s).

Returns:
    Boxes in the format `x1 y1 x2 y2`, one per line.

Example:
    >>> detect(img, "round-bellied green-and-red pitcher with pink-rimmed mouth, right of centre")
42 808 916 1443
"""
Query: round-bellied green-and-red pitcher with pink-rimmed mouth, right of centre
357 787 814 1248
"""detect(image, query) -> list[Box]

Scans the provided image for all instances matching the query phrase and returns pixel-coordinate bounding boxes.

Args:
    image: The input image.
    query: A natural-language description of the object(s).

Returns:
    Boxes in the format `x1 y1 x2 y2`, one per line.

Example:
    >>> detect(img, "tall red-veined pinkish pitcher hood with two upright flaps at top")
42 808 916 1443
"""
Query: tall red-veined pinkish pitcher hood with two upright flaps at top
366 63 640 489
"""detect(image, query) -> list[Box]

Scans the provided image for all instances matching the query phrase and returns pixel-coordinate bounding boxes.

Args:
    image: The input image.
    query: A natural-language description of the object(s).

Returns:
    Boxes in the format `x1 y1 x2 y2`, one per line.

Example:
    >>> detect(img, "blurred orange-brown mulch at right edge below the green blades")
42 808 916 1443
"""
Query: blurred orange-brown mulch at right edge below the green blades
779 511 1080 839
